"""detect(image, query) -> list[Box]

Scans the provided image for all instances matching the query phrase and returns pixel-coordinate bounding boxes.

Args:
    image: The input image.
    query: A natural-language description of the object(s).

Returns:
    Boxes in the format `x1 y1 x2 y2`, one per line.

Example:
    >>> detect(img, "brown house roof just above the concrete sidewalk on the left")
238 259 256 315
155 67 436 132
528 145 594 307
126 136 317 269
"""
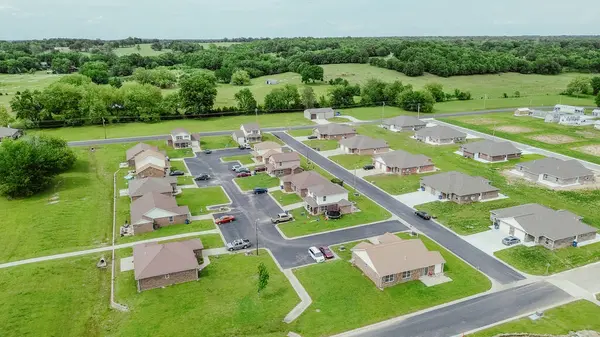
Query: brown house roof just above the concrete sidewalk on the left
130 192 190 224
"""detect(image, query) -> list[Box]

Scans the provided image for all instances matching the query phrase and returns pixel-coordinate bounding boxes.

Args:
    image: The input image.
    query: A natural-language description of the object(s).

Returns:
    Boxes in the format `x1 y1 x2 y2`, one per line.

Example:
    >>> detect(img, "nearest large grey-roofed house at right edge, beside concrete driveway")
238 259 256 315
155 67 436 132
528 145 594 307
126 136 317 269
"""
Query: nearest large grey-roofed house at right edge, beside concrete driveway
490 204 597 249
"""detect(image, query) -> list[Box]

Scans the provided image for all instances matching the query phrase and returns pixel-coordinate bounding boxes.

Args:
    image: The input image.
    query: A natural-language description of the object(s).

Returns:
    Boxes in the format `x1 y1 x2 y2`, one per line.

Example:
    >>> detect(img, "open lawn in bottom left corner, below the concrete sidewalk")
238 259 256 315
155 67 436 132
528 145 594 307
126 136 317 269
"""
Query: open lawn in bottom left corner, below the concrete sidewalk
0 252 110 337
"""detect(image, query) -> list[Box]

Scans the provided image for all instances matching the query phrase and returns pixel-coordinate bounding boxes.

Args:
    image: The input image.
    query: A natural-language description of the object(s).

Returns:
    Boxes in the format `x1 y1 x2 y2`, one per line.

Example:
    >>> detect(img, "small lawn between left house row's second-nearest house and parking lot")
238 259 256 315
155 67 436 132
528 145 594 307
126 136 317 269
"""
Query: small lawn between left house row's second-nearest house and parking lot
175 186 230 215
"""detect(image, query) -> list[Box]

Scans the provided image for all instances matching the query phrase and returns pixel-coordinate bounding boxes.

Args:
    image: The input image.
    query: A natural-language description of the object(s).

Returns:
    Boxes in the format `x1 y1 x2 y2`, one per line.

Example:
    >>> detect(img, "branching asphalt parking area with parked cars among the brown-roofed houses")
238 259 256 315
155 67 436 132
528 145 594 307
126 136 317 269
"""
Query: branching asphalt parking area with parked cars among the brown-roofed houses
184 149 408 269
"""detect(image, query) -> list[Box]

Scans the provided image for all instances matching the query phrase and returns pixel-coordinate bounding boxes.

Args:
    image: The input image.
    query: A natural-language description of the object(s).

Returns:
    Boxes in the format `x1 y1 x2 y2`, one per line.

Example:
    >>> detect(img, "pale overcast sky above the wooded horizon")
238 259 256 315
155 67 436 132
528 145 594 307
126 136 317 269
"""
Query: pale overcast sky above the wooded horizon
0 0 600 40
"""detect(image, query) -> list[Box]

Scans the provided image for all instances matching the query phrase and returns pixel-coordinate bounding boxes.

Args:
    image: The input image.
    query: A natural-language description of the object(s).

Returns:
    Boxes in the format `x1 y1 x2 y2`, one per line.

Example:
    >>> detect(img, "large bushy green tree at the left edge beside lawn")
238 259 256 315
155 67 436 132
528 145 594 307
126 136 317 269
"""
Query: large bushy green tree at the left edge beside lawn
0 135 76 197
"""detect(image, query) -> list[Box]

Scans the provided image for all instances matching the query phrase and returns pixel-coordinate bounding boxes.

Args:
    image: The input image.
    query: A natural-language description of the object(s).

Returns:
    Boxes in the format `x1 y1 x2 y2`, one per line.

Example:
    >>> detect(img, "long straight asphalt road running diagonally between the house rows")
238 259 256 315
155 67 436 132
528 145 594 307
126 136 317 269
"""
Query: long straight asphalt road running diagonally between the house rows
273 132 525 284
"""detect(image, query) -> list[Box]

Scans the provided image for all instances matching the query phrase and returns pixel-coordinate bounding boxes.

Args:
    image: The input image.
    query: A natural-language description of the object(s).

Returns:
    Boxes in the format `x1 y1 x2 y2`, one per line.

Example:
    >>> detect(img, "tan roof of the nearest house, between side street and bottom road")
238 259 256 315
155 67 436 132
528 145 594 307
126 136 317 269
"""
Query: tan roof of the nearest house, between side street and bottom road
352 235 446 277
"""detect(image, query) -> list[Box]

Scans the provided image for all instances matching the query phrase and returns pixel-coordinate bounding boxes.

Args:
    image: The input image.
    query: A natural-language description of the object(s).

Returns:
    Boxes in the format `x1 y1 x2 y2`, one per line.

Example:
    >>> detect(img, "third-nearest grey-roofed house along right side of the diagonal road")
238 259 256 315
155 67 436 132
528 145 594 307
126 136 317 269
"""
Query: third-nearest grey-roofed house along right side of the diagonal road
373 150 435 175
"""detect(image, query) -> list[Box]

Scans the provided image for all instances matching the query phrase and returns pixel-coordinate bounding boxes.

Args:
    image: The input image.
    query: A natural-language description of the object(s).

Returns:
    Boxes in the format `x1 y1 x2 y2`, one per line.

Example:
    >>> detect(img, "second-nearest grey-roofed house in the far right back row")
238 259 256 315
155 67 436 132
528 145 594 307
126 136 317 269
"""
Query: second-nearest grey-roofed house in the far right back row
460 139 521 162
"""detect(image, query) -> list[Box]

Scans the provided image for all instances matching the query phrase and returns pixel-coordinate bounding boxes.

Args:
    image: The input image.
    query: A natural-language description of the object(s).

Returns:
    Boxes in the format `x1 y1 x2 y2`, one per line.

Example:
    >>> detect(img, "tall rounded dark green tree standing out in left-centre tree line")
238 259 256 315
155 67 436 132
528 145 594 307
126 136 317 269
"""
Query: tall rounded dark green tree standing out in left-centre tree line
179 73 217 114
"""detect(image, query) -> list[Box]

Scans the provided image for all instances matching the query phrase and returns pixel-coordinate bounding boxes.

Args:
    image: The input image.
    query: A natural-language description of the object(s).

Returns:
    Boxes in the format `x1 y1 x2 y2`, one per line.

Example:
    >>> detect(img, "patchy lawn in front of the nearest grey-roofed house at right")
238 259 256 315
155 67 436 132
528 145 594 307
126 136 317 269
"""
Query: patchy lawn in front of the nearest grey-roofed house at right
494 243 600 275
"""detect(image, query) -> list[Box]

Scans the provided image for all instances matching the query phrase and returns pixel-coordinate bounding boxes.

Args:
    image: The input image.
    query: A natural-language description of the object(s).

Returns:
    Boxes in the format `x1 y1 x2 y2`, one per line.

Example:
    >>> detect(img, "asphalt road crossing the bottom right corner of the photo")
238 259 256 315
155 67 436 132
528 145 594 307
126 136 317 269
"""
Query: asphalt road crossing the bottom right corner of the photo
339 282 571 337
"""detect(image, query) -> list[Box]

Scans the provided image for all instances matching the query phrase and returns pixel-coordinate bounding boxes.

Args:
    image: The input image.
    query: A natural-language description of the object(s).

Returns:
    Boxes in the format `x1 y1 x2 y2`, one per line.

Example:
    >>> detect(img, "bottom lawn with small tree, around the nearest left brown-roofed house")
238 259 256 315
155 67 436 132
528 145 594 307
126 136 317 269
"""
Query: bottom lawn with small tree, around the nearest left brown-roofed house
113 249 300 337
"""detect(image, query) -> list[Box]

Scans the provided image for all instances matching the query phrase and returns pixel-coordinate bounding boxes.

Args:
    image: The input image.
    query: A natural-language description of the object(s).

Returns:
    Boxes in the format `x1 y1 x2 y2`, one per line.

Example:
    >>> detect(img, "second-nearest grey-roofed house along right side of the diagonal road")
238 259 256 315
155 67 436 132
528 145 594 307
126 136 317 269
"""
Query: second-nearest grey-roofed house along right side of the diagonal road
421 171 499 204
